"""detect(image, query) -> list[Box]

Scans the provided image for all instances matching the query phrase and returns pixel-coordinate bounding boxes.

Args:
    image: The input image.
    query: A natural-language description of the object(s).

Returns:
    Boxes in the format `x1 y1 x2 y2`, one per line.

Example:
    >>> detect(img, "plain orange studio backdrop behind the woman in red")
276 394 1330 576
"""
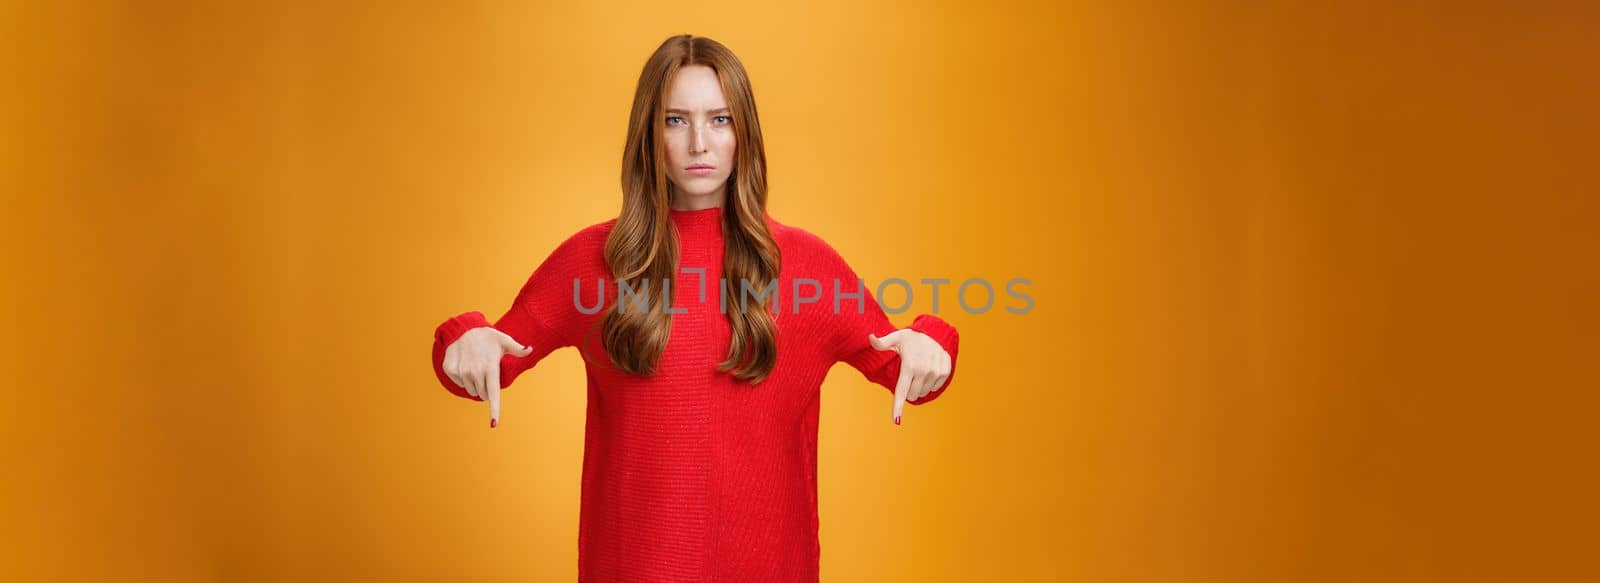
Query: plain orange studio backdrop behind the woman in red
0 2 1600 581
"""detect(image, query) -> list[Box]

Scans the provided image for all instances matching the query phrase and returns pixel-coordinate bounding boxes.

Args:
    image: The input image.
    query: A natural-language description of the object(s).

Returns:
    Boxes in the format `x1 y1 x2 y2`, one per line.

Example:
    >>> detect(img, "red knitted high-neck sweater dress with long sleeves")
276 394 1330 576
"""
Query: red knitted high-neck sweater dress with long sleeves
434 207 958 583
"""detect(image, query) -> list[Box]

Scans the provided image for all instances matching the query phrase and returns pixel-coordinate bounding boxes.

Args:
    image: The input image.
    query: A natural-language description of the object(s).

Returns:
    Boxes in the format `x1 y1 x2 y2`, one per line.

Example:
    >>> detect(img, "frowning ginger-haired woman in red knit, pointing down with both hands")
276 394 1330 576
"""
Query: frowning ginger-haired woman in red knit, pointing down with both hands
434 35 958 581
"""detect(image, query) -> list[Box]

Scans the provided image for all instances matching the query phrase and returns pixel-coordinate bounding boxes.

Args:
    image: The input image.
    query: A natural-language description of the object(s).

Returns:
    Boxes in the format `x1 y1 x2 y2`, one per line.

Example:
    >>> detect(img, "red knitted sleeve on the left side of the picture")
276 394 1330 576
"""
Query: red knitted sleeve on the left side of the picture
434 227 587 400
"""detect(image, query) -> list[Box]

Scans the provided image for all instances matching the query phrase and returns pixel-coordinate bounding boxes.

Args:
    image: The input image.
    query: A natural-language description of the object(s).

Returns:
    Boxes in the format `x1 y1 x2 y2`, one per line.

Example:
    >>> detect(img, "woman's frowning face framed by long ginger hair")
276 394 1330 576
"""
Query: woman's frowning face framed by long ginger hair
662 64 736 207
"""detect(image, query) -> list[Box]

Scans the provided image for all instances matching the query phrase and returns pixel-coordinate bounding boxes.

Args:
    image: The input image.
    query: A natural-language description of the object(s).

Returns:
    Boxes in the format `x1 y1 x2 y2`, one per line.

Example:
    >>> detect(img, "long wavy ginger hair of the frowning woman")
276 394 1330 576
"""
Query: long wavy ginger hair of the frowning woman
600 35 781 384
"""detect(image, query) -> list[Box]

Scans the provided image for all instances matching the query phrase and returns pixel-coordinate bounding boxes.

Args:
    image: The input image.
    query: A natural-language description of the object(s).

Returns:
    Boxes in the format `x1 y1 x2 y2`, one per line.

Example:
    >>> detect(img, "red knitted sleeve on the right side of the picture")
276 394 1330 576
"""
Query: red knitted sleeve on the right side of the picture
822 243 960 405
